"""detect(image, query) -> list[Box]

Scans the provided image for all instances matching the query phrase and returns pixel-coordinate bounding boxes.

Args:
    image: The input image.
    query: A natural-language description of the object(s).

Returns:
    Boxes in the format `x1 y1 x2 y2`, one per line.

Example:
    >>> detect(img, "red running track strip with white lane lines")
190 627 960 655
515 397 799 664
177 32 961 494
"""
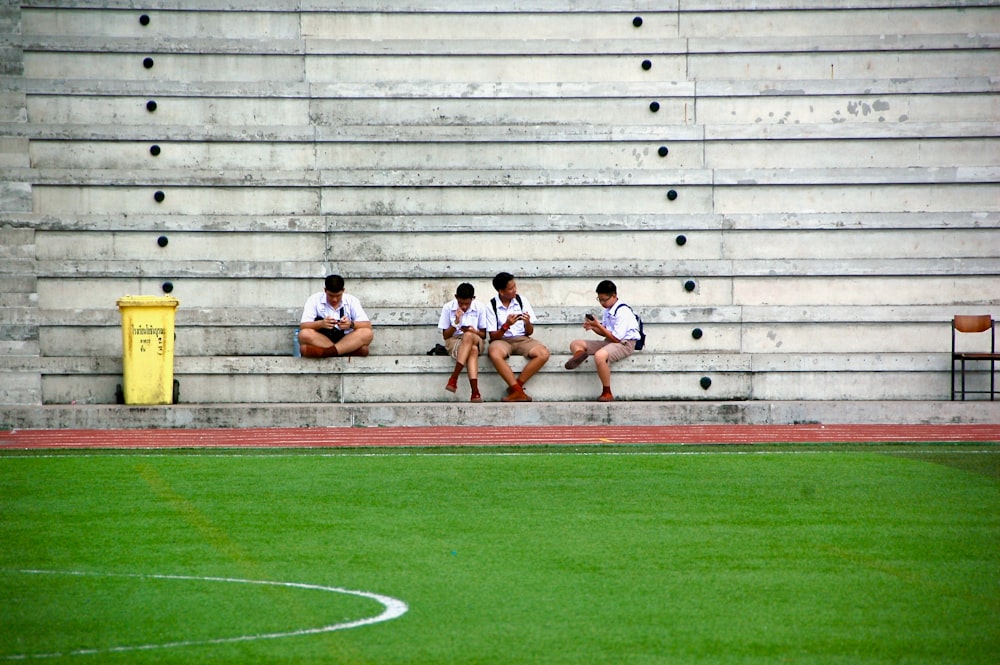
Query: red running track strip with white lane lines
0 424 1000 450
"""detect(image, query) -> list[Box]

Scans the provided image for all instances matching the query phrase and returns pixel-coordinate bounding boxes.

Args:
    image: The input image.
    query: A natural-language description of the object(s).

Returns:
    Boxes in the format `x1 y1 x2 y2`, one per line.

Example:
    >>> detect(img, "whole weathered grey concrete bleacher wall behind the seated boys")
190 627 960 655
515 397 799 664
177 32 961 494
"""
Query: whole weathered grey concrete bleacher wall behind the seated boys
0 0 1000 404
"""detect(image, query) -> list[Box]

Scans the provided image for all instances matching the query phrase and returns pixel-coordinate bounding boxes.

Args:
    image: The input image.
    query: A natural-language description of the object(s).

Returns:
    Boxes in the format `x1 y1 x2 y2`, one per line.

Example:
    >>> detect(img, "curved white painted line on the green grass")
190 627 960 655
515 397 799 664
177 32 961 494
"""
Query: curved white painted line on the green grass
0 570 409 660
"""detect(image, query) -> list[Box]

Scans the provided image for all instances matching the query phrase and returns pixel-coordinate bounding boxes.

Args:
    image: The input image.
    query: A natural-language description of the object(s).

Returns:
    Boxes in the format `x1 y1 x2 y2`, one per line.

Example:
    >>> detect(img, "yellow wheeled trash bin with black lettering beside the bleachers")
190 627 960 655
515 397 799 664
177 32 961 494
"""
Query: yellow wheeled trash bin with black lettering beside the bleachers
118 296 180 404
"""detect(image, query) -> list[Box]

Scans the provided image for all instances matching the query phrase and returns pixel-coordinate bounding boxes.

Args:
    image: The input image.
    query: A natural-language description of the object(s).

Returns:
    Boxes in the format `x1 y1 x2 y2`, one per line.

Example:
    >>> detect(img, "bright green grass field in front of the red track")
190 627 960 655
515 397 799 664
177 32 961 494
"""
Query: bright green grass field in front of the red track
0 444 1000 665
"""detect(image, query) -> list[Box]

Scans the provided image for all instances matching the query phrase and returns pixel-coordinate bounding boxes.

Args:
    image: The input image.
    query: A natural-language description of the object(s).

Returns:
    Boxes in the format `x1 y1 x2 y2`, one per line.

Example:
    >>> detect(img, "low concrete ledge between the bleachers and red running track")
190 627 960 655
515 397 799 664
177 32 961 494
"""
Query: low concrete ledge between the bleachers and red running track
0 400 1000 430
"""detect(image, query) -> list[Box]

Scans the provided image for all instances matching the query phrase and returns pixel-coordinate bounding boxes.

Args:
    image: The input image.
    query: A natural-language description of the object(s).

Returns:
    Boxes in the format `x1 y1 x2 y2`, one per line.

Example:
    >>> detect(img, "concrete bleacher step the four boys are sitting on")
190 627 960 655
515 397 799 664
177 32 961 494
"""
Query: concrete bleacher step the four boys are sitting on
0 351 989 404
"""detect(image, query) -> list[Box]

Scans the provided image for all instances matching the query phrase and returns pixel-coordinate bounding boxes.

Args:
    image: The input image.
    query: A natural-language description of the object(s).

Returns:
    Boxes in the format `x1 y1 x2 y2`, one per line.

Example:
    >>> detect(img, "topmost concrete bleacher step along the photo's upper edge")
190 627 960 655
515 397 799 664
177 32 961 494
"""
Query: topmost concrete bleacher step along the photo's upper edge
20 0 993 41
